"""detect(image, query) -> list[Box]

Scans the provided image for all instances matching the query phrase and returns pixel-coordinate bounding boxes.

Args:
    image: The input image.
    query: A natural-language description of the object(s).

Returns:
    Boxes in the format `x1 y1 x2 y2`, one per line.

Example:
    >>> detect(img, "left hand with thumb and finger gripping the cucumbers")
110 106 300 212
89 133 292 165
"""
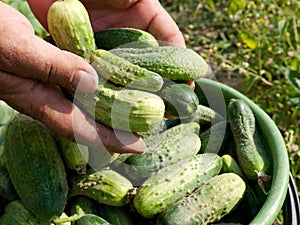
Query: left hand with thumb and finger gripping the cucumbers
0 1 146 152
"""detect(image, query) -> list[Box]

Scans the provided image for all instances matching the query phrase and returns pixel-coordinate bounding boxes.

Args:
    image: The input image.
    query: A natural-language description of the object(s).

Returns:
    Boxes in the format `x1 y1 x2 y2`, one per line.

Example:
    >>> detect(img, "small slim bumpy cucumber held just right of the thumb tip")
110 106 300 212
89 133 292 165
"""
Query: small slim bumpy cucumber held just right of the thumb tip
90 49 164 92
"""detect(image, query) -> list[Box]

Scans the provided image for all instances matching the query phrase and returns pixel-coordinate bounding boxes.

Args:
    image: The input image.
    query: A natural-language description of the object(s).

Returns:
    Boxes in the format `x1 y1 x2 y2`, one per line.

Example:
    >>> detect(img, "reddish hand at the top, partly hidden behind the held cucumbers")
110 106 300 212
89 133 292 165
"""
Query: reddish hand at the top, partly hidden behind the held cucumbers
28 0 185 47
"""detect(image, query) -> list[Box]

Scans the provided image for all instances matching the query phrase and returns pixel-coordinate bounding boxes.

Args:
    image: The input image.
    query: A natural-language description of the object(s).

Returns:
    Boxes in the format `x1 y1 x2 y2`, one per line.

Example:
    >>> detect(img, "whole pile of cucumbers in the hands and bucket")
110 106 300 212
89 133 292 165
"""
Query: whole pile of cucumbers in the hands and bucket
0 0 272 225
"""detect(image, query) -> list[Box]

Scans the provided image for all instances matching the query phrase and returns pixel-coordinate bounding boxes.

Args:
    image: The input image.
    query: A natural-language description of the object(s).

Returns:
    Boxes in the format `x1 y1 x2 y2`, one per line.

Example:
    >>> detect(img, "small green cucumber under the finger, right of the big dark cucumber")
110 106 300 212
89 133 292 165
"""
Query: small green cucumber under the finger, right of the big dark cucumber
55 135 89 174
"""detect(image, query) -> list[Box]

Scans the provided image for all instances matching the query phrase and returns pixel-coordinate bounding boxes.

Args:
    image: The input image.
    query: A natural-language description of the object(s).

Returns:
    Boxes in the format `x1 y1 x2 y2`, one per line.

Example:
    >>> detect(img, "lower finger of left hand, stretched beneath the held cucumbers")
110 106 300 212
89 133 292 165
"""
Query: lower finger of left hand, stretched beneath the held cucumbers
0 71 146 153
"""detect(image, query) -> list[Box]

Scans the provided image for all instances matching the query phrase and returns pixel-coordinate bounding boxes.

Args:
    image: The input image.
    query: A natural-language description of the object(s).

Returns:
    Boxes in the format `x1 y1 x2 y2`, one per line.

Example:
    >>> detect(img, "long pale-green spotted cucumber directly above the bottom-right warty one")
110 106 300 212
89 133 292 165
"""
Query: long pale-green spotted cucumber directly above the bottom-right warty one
133 153 222 218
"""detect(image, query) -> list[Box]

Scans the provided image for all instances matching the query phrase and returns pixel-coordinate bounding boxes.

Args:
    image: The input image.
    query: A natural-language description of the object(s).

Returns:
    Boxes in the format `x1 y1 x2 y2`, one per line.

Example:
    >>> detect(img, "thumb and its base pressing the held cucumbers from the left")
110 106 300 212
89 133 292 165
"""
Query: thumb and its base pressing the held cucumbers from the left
0 7 98 93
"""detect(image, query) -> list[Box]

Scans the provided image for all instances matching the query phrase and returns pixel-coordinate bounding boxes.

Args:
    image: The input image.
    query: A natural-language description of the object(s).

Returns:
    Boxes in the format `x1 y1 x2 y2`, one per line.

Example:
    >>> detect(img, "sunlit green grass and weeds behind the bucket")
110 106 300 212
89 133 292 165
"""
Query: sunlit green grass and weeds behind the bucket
162 0 300 190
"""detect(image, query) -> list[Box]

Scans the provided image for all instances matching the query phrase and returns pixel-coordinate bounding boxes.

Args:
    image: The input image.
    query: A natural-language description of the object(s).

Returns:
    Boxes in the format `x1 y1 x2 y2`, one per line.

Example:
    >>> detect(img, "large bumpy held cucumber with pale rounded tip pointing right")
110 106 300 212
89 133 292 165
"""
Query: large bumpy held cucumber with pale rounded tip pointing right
110 46 208 80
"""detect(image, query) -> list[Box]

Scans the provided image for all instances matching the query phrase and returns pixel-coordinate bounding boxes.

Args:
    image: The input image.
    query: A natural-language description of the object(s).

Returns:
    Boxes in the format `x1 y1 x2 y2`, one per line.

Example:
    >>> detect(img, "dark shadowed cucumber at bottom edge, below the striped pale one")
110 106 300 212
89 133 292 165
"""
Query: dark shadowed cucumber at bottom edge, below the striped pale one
98 204 134 225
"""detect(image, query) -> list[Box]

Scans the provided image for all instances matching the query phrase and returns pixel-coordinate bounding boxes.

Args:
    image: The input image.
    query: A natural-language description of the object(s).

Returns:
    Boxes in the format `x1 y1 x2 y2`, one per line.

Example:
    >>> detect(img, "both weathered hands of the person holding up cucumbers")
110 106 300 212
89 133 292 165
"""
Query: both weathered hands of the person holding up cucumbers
0 0 184 152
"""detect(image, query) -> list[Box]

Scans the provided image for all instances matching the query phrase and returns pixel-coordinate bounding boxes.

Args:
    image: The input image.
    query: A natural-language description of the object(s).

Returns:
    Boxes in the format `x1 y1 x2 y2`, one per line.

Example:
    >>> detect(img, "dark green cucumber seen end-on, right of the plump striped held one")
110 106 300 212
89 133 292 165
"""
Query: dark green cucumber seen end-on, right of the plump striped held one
158 83 199 119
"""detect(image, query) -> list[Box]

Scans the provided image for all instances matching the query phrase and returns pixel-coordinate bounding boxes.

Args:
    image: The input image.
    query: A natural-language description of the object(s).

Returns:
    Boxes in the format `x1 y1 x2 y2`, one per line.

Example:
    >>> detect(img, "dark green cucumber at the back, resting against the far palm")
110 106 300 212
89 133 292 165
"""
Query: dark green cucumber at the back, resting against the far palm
94 27 159 50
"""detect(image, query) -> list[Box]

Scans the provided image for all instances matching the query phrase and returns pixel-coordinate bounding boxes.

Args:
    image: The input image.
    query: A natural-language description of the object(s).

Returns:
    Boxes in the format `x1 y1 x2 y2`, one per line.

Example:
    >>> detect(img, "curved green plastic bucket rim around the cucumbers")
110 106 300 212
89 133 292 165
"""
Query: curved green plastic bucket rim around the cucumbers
195 78 289 225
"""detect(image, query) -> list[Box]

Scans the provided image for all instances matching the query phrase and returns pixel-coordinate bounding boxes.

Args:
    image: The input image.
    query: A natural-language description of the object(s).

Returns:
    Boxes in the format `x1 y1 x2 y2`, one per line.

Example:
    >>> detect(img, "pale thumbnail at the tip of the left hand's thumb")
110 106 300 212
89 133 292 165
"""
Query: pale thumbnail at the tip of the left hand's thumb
72 67 98 93
